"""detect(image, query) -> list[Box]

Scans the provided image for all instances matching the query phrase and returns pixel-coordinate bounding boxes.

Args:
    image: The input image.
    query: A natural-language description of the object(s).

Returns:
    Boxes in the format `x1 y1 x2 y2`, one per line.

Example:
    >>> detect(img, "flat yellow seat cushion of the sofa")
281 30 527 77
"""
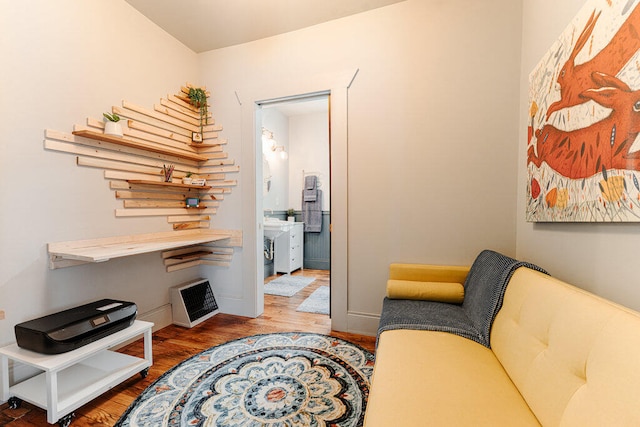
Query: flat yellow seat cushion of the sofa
364 329 539 427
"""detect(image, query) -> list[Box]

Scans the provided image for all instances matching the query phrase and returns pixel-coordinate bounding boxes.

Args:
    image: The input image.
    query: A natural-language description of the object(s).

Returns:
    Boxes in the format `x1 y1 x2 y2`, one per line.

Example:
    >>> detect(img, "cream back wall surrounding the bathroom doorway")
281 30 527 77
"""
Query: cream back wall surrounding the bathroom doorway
200 0 522 332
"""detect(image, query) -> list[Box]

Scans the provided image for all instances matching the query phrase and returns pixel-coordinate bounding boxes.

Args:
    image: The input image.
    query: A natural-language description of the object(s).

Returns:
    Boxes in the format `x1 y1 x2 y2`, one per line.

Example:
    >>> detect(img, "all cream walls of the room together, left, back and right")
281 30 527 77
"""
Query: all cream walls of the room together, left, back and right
0 0 568 344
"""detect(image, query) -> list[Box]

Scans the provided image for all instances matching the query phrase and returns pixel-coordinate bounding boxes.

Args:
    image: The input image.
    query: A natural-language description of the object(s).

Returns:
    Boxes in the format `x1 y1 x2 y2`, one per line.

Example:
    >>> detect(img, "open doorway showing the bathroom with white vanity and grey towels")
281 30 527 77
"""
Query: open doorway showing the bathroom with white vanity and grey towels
255 92 331 316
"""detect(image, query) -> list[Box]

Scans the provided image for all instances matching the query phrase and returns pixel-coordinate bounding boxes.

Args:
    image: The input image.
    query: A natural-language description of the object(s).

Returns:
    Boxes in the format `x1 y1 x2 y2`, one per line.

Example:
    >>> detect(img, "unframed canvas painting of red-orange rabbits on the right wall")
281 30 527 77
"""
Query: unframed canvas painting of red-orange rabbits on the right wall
527 0 640 222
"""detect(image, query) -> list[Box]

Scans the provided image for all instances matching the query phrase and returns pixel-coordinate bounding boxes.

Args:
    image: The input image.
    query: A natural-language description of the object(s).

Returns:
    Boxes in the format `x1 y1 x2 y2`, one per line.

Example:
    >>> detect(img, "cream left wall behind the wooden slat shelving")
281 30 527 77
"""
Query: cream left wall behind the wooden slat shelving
0 0 199 345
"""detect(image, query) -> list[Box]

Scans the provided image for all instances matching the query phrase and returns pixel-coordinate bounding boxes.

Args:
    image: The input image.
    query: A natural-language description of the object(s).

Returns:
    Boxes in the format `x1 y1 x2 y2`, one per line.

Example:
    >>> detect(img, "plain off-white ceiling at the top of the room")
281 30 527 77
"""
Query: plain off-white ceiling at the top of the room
125 0 404 53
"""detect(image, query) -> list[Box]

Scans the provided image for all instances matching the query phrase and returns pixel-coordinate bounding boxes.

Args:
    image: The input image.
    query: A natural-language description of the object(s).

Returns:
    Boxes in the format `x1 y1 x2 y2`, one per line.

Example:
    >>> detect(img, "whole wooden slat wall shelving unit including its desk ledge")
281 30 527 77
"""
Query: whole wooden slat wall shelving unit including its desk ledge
44 85 242 270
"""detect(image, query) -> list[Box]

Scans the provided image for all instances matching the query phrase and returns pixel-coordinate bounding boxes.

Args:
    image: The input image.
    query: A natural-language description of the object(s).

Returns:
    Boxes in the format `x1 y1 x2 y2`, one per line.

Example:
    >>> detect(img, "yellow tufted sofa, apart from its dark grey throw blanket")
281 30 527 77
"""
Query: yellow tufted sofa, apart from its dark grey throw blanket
364 252 640 427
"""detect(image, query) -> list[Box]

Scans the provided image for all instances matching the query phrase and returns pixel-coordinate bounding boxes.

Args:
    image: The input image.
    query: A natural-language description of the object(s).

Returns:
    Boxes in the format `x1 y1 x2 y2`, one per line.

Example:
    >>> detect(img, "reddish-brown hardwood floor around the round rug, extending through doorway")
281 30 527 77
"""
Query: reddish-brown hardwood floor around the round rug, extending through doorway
0 270 375 427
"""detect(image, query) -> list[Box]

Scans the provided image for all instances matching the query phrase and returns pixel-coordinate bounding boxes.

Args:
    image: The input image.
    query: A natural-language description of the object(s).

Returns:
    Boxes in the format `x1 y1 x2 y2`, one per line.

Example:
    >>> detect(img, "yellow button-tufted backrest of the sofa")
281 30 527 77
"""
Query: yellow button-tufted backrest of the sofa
491 267 640 427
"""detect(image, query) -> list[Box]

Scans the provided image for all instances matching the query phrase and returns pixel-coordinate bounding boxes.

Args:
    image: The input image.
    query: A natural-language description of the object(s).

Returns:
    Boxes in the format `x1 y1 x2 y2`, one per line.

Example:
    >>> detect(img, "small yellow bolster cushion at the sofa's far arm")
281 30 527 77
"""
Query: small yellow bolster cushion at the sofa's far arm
387 279 464 304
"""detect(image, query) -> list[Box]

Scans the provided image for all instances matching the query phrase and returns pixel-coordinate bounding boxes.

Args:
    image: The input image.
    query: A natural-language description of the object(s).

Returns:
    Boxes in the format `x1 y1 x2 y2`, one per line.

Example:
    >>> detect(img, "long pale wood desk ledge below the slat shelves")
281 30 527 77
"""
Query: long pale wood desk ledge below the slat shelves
48 229 232 269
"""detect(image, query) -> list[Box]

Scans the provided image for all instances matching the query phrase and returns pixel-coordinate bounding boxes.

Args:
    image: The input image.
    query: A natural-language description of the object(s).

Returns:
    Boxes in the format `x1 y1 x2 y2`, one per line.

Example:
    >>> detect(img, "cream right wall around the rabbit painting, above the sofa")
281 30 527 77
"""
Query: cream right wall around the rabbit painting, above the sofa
517 0 640 310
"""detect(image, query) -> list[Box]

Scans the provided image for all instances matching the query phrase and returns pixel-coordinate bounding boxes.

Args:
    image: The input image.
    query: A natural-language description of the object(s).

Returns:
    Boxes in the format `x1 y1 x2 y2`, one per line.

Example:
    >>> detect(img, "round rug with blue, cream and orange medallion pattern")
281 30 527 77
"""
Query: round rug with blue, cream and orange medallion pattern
116 333 373 427
